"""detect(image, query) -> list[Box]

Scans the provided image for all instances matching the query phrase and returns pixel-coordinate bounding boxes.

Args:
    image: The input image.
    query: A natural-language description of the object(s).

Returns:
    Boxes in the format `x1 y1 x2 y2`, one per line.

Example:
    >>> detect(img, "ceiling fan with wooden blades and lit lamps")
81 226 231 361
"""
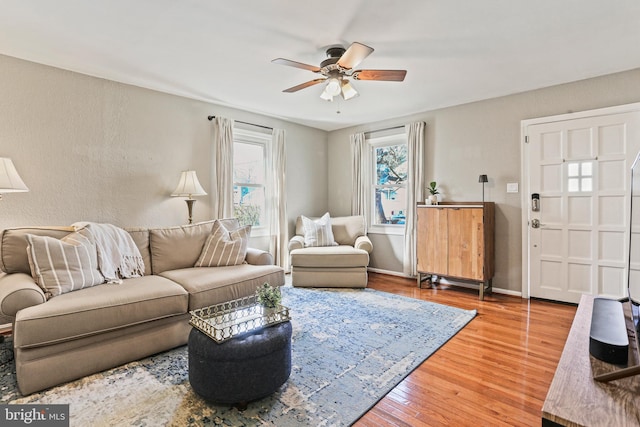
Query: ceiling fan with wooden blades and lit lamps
271 42 407 101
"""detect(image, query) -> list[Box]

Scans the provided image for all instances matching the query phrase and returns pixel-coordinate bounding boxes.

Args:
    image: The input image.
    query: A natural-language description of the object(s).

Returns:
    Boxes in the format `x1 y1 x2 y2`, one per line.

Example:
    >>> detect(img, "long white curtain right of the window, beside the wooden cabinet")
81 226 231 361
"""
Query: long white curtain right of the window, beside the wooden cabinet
403 122 425 276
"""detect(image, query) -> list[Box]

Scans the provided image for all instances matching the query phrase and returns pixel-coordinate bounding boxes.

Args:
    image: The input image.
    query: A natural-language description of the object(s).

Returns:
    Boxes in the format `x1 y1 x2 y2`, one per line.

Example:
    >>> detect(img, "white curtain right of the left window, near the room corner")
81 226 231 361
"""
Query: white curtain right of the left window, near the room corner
267 129 289 272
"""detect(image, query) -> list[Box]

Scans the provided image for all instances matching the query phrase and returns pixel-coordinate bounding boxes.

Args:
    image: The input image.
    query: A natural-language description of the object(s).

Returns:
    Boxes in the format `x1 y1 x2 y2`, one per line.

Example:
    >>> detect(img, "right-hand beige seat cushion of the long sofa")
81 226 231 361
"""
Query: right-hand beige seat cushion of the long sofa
161 264 284 310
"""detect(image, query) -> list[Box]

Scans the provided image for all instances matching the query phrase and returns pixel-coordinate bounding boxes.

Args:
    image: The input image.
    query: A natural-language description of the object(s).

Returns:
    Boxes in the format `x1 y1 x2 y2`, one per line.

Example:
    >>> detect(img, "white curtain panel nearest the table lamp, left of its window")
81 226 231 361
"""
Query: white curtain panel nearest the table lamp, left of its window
211 116 233 218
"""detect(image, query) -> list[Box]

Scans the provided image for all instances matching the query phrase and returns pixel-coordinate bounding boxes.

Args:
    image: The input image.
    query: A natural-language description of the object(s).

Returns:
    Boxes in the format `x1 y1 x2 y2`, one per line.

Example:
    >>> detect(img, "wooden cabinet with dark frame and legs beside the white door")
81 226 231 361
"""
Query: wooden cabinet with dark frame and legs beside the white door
416 202 495 299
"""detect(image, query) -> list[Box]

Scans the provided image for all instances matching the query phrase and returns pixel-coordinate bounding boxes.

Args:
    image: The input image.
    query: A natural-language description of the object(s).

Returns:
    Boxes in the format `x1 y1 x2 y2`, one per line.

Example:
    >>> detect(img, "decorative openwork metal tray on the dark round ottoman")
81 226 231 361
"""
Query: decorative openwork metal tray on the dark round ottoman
189 295 291 343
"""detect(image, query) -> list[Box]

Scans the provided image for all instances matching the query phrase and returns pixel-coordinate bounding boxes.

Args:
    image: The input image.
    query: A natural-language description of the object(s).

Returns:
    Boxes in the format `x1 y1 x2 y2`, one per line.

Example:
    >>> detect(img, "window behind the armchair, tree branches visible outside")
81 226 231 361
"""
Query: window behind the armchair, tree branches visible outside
370 134 407 228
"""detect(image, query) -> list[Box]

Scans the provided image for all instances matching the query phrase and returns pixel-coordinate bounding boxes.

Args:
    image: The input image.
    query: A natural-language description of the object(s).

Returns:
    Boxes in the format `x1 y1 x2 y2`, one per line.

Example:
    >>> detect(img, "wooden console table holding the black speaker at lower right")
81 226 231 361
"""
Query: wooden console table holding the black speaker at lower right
542 295 640 427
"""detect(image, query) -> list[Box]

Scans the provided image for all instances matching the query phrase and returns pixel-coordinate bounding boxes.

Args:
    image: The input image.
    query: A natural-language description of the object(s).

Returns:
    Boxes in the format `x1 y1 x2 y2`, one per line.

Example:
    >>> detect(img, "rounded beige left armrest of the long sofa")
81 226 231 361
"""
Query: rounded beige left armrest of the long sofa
0 273 47 317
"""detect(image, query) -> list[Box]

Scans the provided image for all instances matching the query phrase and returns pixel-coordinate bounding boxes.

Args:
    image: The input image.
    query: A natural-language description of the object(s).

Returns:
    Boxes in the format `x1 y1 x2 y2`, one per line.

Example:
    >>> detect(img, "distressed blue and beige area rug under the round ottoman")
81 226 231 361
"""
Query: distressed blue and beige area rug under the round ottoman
0 287 476 427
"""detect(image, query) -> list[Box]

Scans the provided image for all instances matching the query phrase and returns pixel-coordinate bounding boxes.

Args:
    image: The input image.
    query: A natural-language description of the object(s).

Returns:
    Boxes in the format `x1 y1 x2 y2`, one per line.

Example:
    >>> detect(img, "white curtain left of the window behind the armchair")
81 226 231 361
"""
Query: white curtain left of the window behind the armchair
349 132 371 217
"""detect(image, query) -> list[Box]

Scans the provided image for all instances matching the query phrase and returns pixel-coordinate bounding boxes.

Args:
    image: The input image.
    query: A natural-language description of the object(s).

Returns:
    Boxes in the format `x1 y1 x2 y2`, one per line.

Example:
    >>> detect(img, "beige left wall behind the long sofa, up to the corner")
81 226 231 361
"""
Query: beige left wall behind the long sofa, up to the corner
0 55 327 246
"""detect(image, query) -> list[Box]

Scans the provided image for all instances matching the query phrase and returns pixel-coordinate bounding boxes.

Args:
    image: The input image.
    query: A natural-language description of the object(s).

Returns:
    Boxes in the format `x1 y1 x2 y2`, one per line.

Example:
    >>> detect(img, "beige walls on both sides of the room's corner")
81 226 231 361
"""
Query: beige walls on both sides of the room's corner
0 51 640 298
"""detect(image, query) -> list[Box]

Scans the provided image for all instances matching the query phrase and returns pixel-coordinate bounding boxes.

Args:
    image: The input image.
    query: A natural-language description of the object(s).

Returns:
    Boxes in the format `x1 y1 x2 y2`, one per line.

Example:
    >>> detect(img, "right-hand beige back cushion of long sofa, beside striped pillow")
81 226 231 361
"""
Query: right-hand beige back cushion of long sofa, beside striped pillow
149 218 238 274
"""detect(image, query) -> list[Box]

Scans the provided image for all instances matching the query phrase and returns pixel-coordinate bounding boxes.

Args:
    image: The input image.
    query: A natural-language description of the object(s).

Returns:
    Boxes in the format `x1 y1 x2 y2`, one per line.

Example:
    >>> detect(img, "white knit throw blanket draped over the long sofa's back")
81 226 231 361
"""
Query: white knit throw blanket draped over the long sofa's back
73 222 144 283
